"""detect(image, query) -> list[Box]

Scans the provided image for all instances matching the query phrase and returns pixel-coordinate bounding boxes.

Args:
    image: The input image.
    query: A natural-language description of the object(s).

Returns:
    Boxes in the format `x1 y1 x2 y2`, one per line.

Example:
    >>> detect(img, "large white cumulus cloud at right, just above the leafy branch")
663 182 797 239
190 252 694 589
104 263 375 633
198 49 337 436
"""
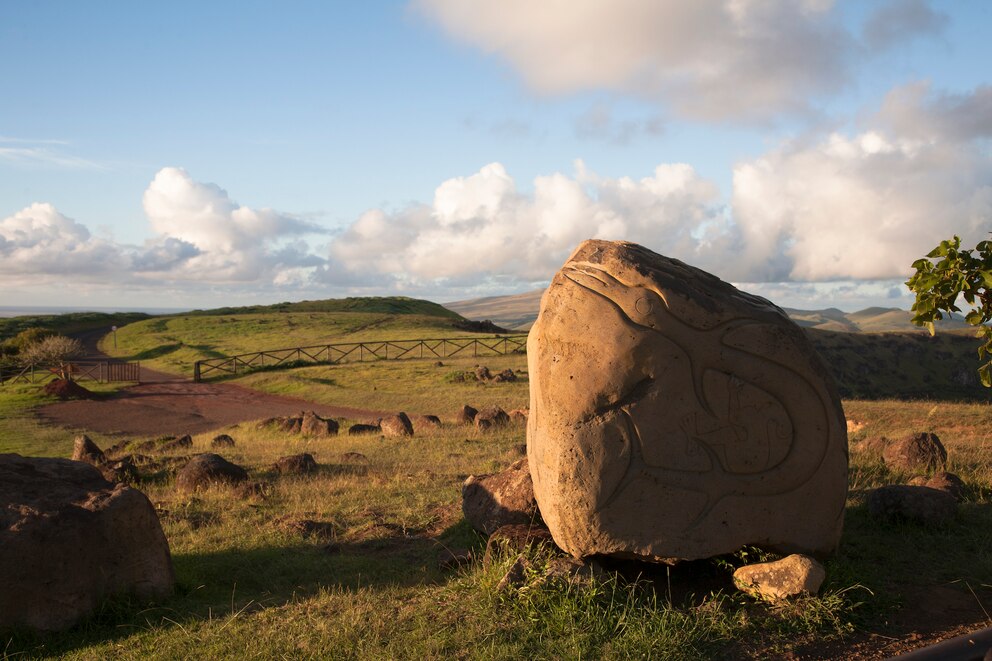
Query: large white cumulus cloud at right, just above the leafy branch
733 85 992 281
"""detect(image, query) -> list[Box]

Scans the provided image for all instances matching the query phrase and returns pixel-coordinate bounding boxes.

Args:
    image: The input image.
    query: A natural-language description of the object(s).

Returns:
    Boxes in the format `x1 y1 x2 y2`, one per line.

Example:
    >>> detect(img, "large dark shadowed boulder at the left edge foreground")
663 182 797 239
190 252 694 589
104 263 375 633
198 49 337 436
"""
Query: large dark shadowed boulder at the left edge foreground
0 454 175 631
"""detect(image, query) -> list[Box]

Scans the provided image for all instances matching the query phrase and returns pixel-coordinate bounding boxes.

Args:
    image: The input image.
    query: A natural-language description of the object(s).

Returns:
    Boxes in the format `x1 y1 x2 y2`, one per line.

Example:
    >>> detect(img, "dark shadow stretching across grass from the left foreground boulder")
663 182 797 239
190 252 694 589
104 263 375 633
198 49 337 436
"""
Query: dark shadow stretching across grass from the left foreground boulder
0 521 479 658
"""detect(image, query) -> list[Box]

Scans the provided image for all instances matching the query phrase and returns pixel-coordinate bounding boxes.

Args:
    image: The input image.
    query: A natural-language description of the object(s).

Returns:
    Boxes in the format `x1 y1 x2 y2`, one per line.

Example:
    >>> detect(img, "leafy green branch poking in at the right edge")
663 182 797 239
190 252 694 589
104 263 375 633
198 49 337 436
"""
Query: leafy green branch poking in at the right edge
906 236 992 387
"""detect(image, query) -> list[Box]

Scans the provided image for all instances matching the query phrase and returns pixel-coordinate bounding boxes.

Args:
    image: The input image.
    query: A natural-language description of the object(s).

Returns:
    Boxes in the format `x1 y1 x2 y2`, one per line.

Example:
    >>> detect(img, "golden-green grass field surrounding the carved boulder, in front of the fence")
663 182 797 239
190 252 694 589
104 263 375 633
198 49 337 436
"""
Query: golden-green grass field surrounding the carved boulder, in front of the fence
0 346 992 659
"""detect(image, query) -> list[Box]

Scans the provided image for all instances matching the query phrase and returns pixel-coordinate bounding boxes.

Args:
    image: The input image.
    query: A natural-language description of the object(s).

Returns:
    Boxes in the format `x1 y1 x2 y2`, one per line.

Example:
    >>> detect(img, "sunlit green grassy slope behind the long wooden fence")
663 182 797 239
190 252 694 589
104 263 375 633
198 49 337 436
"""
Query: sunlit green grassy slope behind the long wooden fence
100 312 508 375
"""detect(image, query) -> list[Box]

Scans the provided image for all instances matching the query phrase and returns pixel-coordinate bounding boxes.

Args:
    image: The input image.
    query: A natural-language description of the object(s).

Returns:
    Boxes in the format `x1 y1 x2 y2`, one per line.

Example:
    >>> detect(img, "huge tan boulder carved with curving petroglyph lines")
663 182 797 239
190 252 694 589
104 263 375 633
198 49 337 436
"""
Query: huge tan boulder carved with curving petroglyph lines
527 241 847 561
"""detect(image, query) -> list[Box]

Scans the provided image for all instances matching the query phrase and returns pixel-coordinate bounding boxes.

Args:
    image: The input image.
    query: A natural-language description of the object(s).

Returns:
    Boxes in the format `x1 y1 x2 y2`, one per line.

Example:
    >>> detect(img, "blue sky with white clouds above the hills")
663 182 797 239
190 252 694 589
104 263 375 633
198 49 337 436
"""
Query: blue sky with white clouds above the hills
0 0 992 311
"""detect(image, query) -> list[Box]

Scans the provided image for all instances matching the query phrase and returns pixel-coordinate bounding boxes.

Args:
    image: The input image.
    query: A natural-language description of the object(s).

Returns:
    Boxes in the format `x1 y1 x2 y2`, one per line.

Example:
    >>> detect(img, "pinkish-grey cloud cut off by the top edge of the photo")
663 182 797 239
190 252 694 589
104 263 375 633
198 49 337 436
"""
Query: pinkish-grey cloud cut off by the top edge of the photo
415 0 860 120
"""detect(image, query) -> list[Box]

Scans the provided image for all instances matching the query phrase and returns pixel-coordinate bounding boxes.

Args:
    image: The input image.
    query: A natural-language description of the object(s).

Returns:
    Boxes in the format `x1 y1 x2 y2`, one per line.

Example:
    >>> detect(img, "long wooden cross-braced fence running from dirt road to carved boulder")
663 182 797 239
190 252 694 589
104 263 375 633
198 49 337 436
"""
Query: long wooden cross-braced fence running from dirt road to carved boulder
193 335 527 382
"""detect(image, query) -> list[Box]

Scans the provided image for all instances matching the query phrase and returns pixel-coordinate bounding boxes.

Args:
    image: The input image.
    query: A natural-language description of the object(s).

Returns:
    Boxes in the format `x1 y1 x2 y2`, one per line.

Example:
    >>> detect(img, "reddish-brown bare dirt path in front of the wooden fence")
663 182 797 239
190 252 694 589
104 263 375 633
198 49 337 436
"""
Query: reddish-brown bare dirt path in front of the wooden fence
36 329 383 435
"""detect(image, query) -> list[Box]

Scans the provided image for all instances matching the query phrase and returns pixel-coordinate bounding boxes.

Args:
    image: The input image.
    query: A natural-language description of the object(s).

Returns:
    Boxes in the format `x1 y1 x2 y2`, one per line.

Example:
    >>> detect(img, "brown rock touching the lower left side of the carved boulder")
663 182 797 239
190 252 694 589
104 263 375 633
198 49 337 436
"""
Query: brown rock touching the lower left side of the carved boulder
462 458 540 535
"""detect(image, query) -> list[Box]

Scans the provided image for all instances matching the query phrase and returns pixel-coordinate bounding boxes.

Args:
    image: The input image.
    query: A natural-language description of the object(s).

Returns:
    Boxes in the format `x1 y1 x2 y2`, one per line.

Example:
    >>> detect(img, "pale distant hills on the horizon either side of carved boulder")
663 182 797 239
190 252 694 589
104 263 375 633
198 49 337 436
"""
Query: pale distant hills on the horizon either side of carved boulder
452 289 970 333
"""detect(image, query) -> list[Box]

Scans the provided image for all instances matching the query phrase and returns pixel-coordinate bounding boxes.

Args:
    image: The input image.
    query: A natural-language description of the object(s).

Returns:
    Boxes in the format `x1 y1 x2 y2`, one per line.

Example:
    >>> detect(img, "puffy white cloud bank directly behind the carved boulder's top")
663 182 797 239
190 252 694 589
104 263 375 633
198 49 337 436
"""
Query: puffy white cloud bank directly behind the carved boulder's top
331 162 726 287
